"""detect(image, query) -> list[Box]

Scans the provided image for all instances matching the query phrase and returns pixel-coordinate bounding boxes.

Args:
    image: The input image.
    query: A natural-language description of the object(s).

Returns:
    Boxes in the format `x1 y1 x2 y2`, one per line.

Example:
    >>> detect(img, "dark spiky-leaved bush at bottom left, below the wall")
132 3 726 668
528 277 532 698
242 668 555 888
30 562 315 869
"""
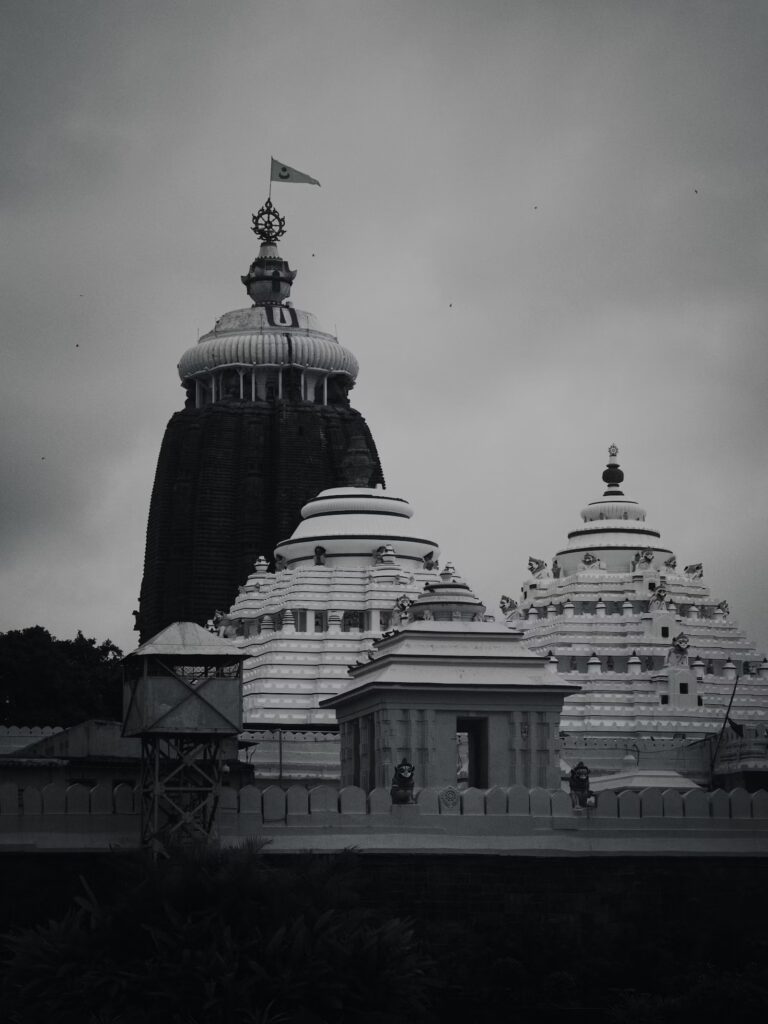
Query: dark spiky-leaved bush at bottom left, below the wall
4 849 429 1024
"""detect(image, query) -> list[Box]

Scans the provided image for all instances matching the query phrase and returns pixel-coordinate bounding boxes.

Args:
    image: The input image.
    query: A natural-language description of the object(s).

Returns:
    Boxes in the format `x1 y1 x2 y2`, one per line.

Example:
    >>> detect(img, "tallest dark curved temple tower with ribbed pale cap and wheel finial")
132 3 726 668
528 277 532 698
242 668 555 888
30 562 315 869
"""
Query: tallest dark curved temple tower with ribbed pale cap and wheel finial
137 200 384 640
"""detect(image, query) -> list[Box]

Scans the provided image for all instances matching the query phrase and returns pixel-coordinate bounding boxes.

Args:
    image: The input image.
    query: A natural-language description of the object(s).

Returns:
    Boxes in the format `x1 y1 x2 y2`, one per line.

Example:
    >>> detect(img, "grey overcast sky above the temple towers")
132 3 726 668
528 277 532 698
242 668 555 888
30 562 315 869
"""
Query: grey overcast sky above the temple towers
0 0 768 648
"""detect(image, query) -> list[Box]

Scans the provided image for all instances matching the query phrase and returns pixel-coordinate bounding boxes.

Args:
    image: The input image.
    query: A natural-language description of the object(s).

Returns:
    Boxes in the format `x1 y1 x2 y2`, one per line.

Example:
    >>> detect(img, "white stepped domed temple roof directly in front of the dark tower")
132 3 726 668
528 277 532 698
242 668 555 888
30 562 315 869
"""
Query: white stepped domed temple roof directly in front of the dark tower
219 487 439 729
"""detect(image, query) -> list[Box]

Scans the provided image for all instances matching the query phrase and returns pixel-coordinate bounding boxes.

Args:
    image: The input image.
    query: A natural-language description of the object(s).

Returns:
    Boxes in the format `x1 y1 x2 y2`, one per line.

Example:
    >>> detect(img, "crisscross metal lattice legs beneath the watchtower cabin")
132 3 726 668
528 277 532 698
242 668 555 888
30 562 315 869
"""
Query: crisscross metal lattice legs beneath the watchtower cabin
141 735 224 856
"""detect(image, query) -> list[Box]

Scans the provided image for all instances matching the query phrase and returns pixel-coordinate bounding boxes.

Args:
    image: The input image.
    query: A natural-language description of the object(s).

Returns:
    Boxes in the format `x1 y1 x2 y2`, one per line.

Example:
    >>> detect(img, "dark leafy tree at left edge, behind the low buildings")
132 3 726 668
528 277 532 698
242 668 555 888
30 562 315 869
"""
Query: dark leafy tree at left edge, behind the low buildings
0 626 123 726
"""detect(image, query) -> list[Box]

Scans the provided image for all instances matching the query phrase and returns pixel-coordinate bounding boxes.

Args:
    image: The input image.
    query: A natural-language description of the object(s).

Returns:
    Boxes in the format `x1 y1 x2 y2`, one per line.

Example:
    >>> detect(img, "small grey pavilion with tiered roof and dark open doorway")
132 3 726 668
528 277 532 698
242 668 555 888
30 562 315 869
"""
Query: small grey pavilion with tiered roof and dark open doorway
324 571 578 790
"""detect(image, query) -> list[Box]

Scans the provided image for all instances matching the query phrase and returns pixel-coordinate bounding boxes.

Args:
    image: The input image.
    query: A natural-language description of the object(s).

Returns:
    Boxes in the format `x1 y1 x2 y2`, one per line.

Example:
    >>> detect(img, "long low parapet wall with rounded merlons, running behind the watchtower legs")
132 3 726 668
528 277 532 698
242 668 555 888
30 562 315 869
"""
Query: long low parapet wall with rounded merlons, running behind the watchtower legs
0 782 768 856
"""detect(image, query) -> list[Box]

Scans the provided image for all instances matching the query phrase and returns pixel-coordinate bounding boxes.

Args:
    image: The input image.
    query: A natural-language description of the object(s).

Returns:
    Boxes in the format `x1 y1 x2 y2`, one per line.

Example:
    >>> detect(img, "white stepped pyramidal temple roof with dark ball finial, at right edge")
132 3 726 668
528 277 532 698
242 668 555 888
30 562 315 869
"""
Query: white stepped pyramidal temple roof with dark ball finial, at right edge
512 446 768 781
